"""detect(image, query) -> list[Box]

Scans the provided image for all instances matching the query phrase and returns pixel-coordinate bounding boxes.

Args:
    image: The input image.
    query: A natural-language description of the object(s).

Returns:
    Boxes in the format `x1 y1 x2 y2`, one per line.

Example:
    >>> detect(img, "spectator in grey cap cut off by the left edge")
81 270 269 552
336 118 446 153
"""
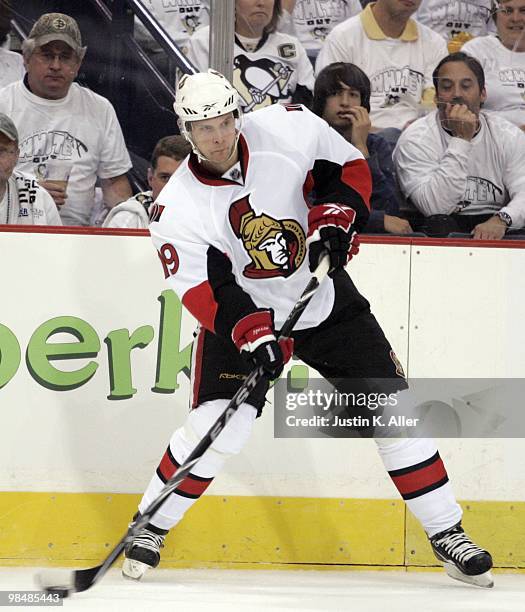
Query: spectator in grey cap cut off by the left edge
0 113 62 225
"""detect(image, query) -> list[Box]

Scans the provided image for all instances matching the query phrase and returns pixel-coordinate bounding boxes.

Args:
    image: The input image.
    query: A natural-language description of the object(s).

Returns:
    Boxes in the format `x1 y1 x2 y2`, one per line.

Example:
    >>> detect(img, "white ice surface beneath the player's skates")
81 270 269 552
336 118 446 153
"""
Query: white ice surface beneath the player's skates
0 568 525 612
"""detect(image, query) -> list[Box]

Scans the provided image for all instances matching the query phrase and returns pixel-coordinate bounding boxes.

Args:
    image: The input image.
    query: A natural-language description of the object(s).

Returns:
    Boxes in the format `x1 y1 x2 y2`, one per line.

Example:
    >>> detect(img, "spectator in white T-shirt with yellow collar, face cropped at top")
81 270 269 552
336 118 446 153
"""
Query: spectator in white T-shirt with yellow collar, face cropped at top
316 0 447 137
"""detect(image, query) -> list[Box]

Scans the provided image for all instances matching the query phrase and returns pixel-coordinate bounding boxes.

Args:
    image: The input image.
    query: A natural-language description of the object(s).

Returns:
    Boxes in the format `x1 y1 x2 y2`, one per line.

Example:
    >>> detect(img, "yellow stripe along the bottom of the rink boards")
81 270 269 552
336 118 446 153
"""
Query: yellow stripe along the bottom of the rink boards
0 492 525 569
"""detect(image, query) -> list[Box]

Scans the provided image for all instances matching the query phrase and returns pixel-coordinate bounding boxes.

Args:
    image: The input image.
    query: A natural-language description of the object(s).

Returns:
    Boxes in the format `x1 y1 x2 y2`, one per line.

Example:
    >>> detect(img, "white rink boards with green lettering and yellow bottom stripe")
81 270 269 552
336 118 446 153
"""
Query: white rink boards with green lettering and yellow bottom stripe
0 231 525 568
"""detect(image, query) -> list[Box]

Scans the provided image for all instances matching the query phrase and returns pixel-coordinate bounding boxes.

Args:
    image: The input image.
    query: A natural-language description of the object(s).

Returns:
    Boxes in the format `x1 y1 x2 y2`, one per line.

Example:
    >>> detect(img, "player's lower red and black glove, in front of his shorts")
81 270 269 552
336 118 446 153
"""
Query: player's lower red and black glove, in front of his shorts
232 310 293 379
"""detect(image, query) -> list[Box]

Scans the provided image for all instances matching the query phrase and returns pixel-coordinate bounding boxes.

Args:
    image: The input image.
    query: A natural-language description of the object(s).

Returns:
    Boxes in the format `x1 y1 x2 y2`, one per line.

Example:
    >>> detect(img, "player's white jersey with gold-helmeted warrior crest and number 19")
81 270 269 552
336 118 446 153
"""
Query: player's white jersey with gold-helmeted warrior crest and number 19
150 104 371 337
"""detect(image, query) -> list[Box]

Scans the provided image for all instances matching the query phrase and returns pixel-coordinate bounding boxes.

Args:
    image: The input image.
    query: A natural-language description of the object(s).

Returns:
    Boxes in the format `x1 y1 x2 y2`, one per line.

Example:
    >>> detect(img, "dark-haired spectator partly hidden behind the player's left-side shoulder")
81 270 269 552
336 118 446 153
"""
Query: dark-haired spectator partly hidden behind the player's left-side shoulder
102 136 191 229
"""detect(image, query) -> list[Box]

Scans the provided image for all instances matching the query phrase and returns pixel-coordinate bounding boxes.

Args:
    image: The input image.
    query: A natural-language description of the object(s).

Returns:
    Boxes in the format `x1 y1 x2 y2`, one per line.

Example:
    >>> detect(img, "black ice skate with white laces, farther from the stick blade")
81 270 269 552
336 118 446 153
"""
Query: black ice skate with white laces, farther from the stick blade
430 523 494 588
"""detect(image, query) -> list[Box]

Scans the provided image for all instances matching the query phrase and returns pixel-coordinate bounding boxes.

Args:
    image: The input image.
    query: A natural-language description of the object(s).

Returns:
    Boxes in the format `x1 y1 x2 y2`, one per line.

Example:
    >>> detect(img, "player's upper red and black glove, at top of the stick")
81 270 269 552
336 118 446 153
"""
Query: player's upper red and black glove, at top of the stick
306 203 359 274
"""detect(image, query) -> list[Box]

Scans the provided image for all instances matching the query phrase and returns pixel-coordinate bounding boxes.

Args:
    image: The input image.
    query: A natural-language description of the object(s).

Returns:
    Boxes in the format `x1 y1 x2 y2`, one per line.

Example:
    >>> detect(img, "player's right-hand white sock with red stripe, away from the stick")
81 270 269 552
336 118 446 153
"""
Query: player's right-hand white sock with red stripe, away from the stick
376 438 462 537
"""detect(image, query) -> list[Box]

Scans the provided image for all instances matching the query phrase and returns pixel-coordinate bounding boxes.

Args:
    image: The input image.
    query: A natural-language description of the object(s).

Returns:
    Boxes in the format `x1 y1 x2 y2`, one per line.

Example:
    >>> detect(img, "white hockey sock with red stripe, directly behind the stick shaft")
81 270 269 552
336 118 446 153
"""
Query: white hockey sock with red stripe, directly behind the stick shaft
139 400 257 529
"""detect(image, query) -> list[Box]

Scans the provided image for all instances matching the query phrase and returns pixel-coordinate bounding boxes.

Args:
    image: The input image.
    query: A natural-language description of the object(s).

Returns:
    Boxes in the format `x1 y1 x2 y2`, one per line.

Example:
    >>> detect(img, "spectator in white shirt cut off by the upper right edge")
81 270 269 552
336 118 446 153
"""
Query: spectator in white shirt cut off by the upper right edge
463 0 525 130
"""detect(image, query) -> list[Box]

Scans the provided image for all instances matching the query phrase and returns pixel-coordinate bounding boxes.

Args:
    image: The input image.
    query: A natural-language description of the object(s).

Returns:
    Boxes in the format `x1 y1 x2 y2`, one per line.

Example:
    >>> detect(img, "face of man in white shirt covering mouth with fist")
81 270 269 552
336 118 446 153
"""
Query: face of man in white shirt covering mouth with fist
436 62 486 120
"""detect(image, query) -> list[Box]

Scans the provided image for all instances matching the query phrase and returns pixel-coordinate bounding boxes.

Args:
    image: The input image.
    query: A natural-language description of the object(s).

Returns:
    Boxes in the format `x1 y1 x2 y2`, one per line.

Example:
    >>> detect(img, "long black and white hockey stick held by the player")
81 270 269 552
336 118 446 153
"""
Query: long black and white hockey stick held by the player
35 256 329 597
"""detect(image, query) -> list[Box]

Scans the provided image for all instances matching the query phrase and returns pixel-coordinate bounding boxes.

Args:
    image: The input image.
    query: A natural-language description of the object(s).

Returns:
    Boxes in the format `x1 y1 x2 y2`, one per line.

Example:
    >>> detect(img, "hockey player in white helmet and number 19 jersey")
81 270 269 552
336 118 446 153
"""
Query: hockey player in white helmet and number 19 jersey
123 71 492 586
